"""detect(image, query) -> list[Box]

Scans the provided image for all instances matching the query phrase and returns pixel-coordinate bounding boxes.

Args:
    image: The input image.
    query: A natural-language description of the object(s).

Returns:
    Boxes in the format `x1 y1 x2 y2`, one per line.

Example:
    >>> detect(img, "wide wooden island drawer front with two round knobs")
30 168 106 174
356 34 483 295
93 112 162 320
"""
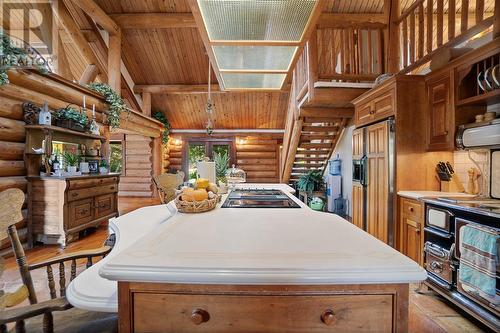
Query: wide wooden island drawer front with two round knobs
133 293 393 333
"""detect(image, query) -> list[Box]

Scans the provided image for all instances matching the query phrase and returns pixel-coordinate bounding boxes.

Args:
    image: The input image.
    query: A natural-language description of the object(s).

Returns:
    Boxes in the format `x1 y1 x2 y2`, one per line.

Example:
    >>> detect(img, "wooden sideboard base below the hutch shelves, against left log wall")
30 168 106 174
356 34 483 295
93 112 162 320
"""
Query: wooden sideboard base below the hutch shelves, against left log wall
27 174 120 246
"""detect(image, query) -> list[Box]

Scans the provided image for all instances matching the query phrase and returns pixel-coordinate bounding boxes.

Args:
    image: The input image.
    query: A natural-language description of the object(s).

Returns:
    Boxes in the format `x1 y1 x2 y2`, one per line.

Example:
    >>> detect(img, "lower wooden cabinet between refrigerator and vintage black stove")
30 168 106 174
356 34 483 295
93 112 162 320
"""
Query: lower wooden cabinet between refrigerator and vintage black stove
399 197 424 265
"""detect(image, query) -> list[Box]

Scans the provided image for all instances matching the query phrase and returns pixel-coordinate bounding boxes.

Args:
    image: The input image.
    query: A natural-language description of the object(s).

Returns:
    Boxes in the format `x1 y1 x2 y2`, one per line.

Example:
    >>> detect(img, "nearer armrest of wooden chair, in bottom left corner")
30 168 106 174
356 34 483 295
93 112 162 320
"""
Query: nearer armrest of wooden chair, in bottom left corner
0 297 71 325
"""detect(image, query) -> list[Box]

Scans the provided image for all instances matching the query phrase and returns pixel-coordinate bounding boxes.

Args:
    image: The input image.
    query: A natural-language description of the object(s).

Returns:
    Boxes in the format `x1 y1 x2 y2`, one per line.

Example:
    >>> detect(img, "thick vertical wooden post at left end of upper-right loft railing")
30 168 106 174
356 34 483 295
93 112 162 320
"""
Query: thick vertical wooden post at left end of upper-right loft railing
384 0 401 73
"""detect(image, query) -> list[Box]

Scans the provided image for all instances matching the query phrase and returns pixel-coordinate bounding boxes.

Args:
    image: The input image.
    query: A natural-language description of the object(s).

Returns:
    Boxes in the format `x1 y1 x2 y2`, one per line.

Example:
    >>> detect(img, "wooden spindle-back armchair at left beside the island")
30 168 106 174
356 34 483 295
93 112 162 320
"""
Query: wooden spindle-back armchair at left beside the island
0 189 116 333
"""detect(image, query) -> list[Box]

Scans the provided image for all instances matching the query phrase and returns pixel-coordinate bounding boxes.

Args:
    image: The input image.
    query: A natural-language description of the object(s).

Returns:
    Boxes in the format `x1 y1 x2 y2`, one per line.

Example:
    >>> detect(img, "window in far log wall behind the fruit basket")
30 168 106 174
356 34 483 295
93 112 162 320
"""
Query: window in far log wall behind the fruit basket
183 139 235 180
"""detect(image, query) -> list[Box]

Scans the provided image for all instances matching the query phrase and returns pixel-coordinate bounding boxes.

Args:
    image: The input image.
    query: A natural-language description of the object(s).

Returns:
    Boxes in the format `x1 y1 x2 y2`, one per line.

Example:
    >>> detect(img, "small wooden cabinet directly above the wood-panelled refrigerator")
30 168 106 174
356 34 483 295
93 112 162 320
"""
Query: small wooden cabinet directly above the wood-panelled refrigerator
354 85 395 126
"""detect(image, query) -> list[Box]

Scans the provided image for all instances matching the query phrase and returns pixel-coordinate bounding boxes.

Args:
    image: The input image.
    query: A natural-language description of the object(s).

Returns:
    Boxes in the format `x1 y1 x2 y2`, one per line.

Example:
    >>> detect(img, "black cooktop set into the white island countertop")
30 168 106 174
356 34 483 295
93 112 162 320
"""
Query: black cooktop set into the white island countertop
222 189 300 208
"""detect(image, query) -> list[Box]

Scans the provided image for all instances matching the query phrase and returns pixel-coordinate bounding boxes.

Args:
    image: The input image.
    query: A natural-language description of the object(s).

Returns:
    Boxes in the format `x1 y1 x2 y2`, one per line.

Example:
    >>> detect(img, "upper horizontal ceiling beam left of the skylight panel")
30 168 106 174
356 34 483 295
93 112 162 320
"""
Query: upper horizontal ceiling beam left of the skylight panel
109 13 196 30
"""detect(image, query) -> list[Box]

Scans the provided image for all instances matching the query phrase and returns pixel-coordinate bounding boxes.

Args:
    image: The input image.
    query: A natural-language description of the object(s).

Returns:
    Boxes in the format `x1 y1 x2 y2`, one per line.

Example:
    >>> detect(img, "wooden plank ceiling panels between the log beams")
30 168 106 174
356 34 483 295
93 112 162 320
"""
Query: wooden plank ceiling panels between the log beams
3 0 495 129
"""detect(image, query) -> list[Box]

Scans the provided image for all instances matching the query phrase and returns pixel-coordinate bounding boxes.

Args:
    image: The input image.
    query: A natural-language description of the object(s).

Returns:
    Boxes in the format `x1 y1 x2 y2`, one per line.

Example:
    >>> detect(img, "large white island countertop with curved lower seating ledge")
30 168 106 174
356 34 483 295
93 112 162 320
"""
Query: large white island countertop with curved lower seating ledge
67 186 426 312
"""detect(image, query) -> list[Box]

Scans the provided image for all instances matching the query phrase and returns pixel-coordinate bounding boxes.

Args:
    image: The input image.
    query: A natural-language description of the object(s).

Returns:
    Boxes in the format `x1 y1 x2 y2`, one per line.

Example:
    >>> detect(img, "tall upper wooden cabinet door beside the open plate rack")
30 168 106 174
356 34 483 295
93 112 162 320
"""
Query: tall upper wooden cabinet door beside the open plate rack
427 76 455 151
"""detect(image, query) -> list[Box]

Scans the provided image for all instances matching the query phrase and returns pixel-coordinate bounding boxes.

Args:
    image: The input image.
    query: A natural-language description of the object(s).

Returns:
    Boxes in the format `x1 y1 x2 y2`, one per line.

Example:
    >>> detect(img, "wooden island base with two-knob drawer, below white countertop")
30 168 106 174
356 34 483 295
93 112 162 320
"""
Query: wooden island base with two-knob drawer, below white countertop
118 282 408 333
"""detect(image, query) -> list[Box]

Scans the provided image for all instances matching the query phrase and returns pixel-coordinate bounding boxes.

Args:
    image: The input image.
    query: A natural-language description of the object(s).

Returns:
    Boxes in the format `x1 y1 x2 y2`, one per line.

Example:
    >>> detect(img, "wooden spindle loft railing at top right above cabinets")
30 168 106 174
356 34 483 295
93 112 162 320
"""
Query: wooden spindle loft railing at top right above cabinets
396 0 495 73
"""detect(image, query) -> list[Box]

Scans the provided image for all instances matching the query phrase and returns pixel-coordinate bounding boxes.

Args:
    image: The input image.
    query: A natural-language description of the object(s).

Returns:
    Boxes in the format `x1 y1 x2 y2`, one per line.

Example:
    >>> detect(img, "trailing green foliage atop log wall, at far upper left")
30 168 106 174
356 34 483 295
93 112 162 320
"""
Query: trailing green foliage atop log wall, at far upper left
0 28 48 86
